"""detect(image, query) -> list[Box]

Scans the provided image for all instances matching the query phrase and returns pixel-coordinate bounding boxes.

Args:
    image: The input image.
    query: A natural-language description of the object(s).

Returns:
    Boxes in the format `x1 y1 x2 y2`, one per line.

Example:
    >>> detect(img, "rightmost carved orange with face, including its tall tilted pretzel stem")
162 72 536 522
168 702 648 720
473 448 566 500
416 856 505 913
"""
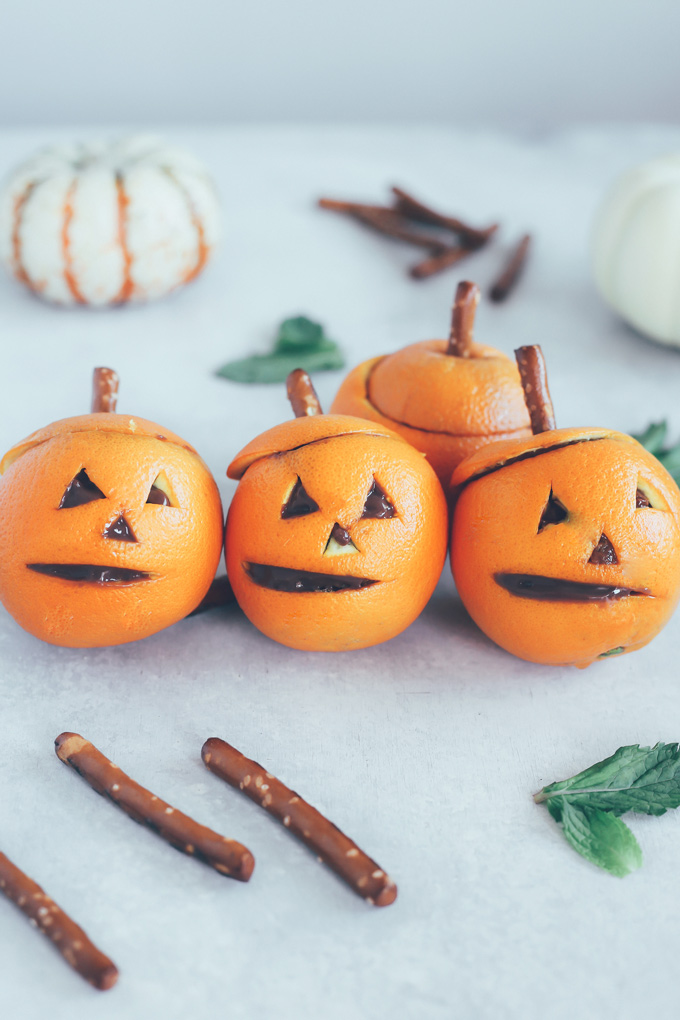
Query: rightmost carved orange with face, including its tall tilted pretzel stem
451 348 680 666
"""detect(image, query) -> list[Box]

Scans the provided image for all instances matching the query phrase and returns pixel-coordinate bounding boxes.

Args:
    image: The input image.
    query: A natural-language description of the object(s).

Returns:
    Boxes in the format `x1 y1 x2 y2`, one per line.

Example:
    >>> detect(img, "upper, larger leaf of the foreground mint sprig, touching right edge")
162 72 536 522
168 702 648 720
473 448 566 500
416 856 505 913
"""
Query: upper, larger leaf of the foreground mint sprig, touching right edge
534 744 680 817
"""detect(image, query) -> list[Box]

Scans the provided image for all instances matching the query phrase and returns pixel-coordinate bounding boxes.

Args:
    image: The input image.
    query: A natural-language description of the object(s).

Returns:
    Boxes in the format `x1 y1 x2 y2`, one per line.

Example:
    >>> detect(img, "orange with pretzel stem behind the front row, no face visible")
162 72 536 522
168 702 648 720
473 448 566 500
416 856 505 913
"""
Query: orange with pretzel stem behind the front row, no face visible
330 283 531 490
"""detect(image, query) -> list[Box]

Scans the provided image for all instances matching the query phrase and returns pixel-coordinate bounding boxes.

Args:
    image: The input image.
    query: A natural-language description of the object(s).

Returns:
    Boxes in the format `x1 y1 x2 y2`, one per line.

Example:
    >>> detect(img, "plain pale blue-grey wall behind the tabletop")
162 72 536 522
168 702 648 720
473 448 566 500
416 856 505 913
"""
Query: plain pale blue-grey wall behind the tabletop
0 0 680 130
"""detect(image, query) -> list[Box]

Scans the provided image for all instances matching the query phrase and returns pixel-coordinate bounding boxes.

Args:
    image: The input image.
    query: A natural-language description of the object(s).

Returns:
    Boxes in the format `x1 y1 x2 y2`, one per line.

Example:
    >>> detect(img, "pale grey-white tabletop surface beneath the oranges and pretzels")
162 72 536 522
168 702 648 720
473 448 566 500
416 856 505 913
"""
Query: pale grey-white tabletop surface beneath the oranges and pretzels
0 128 680 1020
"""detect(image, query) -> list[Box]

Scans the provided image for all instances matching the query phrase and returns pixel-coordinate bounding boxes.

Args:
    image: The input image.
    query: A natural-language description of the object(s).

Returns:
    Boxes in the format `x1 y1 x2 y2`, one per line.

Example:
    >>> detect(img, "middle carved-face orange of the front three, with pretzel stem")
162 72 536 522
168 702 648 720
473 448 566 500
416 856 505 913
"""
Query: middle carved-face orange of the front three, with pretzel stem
225 371 448 652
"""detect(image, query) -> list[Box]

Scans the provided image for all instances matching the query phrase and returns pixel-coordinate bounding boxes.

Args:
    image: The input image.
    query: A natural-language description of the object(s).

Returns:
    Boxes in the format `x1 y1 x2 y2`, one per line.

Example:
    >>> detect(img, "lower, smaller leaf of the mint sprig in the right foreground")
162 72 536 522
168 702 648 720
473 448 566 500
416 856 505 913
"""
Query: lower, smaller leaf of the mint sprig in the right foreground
562 801 642 878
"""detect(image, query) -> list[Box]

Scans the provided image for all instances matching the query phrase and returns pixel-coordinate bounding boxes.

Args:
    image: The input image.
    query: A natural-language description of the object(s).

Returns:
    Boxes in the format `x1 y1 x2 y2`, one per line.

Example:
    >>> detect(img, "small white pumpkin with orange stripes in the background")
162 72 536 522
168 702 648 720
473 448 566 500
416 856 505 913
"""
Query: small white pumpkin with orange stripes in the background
0 136 219 305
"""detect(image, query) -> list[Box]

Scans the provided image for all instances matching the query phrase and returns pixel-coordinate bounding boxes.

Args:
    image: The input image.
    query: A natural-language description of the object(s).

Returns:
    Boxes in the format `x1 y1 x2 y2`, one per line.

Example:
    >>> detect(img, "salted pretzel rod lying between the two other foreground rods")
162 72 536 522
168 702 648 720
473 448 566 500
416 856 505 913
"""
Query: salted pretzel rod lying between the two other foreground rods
54 733 255 882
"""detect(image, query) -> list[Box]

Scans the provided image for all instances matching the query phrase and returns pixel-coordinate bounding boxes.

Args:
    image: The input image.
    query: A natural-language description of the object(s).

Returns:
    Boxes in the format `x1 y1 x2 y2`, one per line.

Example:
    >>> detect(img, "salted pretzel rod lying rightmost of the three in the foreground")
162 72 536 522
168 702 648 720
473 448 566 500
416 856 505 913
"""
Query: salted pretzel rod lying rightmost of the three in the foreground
201 736 397 907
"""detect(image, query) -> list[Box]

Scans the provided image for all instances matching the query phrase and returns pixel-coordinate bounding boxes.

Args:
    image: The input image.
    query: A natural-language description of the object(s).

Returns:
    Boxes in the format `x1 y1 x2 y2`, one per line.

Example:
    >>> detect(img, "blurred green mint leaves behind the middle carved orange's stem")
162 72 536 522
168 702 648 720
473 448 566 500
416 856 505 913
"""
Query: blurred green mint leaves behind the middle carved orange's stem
216 315 345 383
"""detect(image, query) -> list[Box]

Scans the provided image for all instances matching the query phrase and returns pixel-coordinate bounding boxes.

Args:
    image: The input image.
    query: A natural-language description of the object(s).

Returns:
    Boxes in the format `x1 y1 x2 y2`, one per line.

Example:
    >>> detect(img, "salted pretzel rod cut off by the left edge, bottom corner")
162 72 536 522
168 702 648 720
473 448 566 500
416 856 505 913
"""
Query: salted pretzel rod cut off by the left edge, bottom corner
0 854 118 991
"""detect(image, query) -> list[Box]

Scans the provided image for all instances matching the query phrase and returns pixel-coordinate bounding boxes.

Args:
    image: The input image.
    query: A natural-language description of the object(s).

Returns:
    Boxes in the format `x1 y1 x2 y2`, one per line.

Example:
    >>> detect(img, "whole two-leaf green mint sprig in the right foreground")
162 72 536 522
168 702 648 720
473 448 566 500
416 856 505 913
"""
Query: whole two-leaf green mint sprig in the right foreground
534 744 680 877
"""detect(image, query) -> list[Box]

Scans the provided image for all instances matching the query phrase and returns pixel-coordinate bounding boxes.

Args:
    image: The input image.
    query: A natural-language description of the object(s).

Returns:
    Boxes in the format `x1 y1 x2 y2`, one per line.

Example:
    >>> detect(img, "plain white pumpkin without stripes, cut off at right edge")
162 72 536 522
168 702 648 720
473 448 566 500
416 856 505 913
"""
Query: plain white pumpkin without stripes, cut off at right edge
592 155 680 346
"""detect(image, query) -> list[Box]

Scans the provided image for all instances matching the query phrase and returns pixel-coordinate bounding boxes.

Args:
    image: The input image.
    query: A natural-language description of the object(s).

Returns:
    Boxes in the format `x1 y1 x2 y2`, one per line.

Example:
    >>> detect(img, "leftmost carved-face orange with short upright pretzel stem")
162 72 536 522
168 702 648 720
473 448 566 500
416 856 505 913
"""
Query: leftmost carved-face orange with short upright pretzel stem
0 368 222 648
